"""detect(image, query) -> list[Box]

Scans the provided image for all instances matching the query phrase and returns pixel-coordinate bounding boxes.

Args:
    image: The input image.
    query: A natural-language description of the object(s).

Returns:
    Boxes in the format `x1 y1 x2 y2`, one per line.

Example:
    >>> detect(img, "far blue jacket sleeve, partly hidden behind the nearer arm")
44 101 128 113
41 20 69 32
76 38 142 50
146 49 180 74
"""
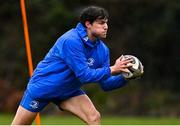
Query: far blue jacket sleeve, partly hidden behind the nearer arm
100 47 127 91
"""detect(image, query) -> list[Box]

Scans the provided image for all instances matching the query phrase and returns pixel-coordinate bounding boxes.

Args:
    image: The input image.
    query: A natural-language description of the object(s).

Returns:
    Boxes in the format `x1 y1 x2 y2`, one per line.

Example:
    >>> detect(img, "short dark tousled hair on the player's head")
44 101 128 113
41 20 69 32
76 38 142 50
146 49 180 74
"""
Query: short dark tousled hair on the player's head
80 6 109 26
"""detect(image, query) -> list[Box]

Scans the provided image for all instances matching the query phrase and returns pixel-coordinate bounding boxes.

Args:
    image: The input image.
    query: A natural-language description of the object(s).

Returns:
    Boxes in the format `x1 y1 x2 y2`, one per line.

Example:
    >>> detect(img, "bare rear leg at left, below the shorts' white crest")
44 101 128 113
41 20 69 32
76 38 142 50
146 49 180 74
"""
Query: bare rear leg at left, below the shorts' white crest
12 106 37 125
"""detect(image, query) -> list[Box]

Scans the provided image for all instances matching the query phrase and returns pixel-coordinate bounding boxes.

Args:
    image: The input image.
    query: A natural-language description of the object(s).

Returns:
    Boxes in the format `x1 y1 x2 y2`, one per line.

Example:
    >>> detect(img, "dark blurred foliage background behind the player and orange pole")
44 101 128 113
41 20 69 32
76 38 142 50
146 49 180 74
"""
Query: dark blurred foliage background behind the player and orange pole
0 0 180 124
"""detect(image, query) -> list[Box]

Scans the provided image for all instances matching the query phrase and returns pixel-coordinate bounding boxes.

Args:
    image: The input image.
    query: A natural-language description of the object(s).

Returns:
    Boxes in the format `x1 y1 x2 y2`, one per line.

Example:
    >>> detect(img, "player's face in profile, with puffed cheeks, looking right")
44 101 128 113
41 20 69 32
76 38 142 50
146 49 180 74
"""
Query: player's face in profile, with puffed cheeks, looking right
89 19 108 38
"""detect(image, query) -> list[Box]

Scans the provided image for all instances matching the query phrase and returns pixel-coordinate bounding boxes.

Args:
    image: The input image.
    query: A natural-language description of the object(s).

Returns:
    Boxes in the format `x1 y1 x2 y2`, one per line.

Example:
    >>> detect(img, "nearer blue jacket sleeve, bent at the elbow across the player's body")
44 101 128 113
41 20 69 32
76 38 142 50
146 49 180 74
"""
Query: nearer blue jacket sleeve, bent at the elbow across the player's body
62 39 111 83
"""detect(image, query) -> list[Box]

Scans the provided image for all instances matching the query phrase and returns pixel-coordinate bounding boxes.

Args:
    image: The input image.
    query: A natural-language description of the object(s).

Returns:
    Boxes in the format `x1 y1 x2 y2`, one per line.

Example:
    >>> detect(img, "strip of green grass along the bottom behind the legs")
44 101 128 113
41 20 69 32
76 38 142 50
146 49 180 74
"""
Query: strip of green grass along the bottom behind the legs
0 114 180 125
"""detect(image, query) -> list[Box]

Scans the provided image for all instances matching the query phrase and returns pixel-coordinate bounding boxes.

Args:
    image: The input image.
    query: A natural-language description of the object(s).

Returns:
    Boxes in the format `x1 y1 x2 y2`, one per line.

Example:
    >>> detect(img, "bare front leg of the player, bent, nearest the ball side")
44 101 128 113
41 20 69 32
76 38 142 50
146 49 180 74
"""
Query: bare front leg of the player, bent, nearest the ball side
60 94 100 125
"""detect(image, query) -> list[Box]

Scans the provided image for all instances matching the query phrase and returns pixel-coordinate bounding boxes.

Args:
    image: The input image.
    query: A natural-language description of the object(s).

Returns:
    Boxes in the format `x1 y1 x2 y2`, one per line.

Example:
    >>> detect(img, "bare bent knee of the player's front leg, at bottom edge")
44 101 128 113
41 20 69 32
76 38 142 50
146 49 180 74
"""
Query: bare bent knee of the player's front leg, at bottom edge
88 111 101 124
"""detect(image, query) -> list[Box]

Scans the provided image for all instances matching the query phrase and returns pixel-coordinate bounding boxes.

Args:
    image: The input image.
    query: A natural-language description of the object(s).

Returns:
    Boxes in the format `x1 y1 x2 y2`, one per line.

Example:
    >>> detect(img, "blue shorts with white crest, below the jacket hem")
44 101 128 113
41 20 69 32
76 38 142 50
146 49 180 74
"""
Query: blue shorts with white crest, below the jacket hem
20 89 85 112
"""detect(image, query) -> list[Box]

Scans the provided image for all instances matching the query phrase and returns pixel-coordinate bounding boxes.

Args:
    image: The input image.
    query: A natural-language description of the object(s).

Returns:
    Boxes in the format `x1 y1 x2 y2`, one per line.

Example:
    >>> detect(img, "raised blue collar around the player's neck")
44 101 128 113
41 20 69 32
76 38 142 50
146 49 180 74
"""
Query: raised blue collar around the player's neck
76 23 100 48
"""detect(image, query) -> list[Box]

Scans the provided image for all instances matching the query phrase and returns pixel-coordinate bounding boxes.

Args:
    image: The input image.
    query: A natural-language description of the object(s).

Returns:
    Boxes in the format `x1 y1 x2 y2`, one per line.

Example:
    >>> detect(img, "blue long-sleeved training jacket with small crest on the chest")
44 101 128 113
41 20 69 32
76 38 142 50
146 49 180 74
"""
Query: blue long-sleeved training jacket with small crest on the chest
27 23 127 99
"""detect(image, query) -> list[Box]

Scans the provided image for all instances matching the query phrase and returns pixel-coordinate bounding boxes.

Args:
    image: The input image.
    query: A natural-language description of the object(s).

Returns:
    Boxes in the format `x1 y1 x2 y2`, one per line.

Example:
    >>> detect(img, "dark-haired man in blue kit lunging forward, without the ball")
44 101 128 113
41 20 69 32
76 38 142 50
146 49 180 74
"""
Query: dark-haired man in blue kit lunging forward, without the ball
12 6 136 125
